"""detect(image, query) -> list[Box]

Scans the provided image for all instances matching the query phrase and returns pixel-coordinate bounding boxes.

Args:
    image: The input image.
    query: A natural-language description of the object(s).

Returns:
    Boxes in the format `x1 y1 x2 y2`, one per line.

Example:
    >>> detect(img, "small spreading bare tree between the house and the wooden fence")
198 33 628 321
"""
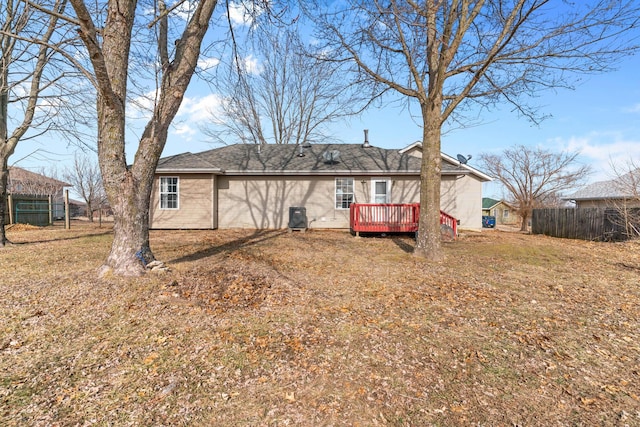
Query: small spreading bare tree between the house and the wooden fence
479 145 591 231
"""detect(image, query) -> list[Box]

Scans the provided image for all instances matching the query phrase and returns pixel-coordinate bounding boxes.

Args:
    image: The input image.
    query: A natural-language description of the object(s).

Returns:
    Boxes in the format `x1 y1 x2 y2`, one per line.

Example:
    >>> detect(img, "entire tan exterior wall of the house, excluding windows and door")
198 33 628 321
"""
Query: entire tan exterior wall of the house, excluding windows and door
150 174 482 230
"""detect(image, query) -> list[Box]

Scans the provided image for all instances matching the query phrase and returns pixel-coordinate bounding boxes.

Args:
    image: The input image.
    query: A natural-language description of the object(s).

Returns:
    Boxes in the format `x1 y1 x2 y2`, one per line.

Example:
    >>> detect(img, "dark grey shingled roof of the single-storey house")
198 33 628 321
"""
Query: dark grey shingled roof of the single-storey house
157 144 469 175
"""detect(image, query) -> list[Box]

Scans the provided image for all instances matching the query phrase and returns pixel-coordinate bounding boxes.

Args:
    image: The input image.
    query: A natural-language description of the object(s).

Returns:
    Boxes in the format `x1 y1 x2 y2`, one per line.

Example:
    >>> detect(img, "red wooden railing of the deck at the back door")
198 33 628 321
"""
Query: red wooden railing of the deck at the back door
349 203 458 236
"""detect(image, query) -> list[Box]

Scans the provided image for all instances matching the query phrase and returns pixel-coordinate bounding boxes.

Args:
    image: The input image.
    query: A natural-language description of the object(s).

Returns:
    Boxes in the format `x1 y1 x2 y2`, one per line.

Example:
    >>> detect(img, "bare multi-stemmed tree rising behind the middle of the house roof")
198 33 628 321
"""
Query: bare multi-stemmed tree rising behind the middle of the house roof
205 22 361 144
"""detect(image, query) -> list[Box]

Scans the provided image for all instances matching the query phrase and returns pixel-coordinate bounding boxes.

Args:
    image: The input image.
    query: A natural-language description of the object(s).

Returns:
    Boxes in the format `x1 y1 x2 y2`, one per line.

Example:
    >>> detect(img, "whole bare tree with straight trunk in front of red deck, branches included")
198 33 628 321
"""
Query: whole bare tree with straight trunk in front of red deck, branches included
308 0 640 260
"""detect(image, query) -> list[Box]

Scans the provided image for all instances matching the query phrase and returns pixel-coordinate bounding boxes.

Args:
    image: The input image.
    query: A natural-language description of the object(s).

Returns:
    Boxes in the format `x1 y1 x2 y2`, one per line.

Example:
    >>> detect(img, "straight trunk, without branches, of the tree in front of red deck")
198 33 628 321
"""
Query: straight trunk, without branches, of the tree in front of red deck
414 102 444 261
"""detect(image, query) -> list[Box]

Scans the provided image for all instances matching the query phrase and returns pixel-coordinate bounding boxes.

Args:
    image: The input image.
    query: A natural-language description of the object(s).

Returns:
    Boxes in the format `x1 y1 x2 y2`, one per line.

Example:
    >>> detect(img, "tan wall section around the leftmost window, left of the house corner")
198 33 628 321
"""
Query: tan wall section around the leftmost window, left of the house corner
149 174 217 229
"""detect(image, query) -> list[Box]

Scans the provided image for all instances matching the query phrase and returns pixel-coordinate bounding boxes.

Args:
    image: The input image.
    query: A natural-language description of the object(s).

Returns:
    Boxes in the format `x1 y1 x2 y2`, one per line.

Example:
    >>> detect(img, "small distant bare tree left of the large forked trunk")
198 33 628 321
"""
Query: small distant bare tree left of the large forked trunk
64 154 107 222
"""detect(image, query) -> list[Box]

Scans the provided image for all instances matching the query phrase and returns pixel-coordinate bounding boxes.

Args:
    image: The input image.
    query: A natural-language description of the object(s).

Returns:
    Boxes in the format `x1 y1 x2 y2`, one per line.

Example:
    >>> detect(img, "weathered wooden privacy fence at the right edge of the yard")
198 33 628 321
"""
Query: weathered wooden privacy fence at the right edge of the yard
531 208 640 241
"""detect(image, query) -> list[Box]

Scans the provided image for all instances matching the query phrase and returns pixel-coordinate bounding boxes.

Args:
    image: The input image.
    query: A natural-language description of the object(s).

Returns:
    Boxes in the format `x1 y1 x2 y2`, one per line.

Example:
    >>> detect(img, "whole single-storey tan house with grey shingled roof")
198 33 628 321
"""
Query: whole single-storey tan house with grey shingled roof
150 144 491 229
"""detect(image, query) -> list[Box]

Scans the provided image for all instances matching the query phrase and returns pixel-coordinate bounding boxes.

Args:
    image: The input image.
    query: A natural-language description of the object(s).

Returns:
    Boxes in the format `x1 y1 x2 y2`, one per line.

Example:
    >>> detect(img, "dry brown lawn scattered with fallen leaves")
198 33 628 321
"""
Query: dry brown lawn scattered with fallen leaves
0 224 640 426
